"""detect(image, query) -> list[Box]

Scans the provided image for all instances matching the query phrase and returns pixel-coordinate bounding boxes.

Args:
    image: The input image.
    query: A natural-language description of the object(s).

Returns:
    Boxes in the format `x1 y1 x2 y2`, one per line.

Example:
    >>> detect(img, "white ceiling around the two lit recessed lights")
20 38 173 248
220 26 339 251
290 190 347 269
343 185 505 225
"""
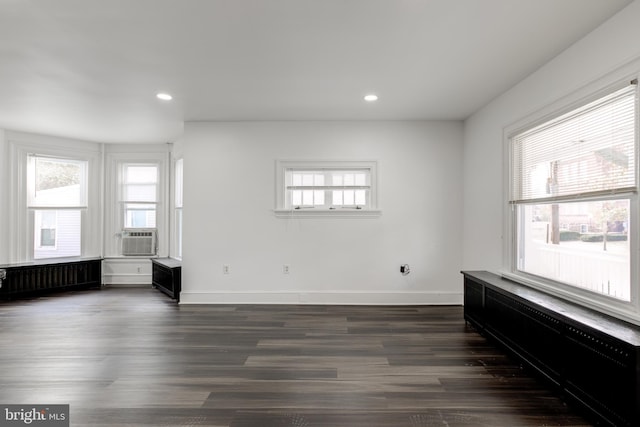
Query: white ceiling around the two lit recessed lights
0 0 631 142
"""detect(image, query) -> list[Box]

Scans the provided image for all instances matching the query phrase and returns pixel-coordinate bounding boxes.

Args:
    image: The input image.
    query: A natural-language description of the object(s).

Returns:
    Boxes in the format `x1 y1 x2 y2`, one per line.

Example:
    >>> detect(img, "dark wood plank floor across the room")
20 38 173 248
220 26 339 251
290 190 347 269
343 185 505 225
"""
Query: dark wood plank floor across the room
0 288 590 427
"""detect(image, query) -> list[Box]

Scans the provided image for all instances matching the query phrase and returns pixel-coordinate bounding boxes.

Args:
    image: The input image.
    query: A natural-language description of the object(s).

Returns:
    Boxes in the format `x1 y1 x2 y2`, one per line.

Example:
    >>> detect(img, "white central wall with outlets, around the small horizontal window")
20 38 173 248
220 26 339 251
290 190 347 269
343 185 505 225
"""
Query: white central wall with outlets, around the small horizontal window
181 122 462 304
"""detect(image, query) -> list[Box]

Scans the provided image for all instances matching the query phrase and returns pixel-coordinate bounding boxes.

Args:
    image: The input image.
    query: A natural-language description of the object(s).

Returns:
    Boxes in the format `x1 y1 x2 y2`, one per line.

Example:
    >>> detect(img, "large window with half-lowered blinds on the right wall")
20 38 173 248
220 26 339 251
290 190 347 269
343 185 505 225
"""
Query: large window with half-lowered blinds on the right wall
509 80 639 302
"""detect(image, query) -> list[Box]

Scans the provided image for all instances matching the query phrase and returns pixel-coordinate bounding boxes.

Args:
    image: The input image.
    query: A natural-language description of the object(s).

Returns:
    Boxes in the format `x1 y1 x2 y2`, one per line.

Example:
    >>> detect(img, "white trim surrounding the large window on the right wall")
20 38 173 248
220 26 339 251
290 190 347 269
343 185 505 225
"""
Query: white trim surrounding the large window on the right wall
500 72 640 325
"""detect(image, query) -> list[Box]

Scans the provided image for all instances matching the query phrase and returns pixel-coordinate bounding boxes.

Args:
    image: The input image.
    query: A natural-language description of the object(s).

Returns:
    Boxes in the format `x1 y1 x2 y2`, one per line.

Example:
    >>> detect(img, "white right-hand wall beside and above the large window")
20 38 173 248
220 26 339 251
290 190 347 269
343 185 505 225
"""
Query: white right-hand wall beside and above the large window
463 1 640 271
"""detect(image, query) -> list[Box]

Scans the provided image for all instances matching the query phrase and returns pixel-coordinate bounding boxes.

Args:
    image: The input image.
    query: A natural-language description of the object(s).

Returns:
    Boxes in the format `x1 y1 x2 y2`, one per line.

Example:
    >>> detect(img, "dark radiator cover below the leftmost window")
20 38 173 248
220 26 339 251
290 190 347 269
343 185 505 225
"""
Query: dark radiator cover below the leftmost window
0 258 102 299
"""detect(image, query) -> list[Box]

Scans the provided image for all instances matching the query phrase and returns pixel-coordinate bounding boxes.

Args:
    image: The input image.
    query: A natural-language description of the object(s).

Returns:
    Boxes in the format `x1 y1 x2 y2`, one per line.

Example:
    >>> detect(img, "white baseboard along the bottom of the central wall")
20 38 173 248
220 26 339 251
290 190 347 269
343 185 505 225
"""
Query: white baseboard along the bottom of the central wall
180 291 463 305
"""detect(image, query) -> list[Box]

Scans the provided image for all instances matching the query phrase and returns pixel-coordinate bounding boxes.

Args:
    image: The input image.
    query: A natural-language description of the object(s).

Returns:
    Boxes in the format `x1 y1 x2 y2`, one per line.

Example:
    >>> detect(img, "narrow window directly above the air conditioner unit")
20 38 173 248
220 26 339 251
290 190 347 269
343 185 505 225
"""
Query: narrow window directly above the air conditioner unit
122 164 158 228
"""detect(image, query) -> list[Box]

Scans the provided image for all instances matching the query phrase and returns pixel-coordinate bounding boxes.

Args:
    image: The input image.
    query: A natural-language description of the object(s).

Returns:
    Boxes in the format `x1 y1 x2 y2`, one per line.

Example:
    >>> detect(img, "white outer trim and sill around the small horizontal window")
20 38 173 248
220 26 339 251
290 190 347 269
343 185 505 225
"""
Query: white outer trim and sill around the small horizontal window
274 160 382 218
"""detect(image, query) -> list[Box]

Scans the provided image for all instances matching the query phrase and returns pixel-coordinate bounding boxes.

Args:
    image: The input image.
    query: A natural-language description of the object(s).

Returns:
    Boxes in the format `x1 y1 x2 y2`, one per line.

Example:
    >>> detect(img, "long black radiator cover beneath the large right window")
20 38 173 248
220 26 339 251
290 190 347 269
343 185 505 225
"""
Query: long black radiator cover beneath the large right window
463 271 640 426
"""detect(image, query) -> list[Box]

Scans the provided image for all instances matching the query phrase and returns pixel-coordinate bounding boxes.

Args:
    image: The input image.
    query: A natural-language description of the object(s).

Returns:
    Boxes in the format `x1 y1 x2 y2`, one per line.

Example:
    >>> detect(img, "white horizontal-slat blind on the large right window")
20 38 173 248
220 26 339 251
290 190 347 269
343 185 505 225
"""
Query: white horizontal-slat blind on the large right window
510 81 637 203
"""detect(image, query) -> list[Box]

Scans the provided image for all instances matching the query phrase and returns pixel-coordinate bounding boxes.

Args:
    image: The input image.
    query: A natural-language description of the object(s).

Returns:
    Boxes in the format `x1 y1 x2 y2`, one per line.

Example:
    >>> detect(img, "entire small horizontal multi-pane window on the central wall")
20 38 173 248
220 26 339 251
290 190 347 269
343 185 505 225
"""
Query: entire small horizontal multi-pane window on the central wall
276 161 379 216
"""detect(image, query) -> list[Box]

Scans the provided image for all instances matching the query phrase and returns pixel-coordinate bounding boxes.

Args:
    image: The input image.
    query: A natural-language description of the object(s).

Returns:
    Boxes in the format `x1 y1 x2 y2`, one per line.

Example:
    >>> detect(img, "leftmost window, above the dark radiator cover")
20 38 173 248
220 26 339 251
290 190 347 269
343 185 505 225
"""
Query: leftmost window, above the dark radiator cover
27 154 88 259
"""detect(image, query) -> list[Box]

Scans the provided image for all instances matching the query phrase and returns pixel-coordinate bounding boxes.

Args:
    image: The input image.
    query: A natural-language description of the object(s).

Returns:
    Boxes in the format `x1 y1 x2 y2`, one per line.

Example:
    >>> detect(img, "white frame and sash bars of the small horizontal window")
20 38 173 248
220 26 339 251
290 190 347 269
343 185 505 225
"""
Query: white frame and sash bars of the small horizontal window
274 160 382 218
